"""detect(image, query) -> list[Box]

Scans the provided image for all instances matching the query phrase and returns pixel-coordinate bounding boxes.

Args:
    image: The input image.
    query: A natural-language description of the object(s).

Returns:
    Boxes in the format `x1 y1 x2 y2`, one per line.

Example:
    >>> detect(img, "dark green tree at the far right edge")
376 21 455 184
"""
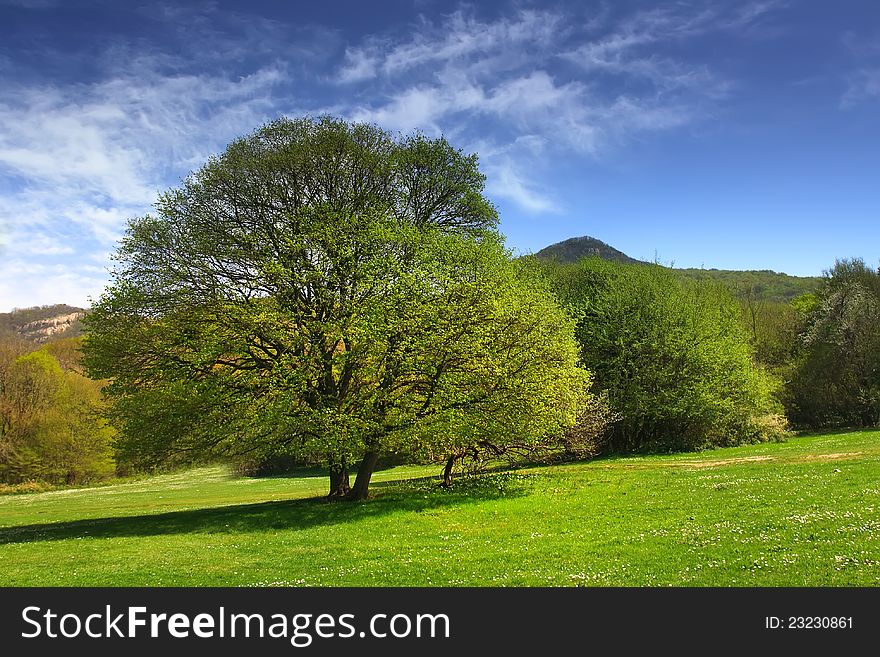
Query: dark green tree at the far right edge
788 260 880 428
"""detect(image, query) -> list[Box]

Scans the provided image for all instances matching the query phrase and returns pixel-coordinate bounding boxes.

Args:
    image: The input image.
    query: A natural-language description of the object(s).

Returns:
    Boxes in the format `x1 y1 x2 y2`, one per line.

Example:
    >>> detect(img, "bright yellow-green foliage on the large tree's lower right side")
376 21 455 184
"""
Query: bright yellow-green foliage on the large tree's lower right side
402 252 590 472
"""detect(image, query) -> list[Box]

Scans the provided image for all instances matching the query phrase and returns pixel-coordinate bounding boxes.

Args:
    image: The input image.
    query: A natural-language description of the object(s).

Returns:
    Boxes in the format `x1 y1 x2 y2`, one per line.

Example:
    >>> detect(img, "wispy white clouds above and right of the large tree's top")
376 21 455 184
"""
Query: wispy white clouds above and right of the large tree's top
332 2 756 212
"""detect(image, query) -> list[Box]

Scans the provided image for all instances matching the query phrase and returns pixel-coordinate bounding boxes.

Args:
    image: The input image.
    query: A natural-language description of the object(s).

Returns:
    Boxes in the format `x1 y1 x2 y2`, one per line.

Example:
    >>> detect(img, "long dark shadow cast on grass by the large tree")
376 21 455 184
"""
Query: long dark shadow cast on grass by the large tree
0 475 528 545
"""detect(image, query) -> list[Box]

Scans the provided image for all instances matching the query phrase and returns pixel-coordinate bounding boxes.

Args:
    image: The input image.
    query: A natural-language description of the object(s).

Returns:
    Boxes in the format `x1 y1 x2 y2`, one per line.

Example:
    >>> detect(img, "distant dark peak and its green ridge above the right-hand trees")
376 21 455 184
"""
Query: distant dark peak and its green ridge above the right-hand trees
534 235 821 303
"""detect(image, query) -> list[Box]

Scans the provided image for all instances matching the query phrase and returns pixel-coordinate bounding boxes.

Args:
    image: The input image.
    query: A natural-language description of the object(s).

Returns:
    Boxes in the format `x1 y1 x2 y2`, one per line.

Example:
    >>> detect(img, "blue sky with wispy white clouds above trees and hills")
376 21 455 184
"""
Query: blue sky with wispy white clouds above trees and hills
0 0 880 312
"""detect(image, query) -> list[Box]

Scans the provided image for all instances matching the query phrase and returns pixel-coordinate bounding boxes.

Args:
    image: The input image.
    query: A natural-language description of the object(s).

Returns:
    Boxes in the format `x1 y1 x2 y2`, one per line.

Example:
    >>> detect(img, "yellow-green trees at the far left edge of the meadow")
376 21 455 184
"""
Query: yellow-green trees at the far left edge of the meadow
0 347 115 484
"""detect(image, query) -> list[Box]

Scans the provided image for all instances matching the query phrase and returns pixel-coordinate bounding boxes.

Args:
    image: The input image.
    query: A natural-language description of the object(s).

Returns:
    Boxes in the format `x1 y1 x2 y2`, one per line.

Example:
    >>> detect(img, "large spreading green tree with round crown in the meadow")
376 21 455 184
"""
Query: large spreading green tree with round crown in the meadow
84 118 586 499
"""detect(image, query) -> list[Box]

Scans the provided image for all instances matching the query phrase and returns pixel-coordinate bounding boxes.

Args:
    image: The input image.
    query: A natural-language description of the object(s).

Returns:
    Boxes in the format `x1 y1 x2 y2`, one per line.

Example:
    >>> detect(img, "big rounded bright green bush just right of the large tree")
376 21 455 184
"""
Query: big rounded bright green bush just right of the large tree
556 259 782 451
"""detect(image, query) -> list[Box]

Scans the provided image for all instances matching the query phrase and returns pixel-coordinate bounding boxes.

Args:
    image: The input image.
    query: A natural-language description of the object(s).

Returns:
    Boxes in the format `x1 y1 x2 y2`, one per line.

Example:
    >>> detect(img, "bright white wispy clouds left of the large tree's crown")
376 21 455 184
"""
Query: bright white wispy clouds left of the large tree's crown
0 5 296 307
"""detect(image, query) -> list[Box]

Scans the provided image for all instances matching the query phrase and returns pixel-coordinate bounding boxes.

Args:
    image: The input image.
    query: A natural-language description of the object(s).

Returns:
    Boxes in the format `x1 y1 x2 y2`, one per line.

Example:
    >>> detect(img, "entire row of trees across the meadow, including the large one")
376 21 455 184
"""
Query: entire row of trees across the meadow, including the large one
0 118 880 499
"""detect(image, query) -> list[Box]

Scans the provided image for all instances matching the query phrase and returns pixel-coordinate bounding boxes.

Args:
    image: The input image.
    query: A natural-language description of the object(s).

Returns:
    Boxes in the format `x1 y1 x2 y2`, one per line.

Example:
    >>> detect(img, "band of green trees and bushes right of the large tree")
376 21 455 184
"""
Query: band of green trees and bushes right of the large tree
545 259 880 440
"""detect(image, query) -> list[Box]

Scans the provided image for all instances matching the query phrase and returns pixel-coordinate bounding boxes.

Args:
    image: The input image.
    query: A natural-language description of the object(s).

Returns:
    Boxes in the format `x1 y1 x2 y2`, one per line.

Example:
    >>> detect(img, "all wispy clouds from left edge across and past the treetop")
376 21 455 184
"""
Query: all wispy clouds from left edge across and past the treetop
0 0 796 306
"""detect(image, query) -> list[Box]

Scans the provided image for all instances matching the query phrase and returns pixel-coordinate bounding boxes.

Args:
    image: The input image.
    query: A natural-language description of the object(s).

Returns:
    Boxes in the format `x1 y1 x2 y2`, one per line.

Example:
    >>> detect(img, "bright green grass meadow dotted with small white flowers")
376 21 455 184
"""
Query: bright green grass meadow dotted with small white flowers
0 431 880 586
